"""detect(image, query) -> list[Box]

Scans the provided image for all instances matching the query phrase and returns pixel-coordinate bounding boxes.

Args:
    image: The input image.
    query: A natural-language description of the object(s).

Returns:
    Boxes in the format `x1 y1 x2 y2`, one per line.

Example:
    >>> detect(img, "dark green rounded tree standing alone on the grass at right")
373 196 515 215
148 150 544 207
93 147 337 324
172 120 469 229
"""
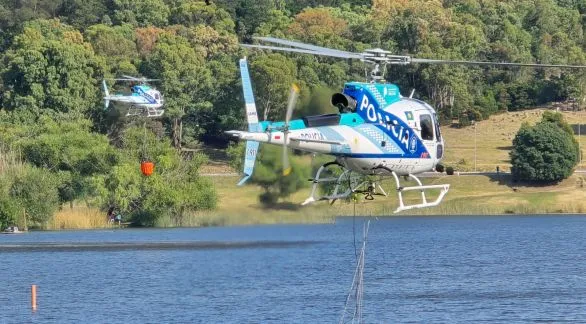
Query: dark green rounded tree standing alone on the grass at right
510 112 579 183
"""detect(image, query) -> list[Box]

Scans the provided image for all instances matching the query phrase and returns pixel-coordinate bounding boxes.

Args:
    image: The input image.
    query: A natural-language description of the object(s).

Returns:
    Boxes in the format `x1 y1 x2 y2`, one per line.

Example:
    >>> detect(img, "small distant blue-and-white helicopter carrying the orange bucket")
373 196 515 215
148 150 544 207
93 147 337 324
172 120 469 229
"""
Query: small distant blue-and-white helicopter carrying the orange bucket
102 75 165 117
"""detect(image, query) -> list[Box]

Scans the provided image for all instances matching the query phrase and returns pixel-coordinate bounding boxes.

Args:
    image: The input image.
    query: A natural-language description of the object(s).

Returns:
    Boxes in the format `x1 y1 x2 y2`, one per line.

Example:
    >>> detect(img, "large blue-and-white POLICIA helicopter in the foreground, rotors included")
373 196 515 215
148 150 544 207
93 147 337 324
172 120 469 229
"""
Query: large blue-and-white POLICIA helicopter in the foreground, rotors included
226 37 586 213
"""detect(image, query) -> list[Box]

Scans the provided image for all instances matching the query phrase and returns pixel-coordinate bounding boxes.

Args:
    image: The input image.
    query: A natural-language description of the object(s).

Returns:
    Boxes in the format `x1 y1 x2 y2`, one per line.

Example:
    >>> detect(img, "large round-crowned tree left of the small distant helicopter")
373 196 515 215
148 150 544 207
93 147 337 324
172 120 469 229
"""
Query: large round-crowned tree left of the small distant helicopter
1 20 105 118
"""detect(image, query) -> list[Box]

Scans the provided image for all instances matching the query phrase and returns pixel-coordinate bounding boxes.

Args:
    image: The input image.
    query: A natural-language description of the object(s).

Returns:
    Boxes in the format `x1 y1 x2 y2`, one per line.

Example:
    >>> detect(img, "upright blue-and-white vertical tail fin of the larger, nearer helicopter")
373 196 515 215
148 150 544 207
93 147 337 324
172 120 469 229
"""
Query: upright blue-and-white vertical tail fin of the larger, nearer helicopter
238 58 262 186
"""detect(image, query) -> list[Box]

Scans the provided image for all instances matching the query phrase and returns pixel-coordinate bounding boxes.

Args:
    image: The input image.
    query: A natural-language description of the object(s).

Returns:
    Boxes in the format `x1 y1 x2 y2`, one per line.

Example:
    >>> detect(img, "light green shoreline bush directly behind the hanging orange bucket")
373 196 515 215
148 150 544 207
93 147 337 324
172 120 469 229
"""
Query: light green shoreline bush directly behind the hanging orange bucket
100 127 217 226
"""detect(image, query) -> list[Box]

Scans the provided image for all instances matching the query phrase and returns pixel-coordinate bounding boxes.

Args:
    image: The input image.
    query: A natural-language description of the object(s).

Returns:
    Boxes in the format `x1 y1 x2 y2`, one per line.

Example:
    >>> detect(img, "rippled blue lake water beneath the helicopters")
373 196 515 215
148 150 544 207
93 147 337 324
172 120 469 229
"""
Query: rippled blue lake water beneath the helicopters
0 216 586 323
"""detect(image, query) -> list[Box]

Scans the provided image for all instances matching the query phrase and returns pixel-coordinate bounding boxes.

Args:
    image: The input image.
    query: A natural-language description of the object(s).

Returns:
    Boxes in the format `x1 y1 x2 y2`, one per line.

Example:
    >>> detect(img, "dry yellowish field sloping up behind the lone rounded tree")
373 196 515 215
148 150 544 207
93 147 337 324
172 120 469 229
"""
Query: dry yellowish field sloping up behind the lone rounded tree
442 109 586 171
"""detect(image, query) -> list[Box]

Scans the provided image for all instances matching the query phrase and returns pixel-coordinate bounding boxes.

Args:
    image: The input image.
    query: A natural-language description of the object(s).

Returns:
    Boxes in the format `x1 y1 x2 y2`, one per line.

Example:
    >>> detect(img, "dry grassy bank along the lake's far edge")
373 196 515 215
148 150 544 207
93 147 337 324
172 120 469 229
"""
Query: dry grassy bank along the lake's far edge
48 174 586 229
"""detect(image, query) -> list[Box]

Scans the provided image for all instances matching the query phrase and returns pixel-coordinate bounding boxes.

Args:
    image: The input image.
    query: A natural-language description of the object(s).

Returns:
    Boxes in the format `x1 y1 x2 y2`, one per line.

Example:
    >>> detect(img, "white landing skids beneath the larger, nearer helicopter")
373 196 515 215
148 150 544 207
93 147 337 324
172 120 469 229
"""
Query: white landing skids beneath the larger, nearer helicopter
302 161 450 213
